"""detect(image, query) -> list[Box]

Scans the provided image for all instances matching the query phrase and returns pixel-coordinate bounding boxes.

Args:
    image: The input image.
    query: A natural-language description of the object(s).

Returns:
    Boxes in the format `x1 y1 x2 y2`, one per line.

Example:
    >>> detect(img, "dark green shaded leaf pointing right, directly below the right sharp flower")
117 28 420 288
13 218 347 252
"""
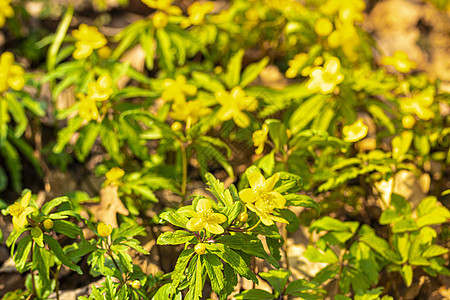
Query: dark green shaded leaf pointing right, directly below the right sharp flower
216 233 279 268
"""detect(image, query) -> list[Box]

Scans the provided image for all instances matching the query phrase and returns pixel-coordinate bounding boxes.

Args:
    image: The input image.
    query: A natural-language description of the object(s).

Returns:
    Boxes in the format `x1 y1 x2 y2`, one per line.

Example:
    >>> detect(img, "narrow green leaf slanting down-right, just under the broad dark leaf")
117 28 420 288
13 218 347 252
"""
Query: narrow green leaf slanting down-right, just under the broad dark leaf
206 244 258 283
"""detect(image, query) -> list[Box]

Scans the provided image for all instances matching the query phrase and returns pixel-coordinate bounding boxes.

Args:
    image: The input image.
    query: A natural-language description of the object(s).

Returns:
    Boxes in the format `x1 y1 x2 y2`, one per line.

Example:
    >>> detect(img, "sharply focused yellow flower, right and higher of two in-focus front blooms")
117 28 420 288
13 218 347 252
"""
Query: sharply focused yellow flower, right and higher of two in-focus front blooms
239 172 288 226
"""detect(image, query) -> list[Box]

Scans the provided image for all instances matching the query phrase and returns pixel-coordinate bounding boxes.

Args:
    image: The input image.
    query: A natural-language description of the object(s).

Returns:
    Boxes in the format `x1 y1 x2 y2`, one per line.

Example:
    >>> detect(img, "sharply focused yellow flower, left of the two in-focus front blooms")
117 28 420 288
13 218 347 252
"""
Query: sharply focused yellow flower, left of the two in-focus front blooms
186 199 227 234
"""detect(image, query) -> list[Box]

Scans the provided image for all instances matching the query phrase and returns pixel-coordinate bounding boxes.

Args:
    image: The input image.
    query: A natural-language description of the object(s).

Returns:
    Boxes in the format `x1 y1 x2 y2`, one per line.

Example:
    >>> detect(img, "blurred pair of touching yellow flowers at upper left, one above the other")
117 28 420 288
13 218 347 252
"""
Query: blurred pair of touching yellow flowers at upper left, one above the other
77 74 113 121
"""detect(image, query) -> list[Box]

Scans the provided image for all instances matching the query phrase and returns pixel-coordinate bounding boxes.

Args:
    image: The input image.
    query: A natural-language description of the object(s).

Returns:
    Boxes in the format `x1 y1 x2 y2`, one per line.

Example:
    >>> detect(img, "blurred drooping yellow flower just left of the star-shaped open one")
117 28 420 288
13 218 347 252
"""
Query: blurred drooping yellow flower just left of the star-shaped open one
169 100 211 129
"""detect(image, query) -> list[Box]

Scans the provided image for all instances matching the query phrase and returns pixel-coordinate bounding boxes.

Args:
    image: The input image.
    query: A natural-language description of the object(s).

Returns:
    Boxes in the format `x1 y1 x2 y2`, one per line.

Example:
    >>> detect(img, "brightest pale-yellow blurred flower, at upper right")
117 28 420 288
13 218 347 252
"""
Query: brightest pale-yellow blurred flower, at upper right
306 57 344 94
